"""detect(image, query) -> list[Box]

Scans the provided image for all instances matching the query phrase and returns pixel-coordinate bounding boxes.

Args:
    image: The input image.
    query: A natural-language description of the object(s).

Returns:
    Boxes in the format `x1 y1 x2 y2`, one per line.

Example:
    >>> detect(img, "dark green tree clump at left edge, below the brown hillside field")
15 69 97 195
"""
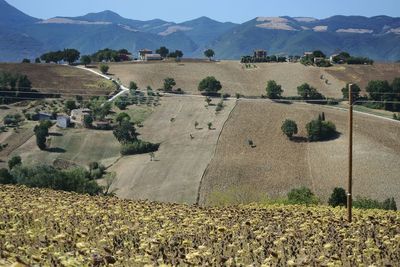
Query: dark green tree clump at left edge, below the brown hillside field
0 71 40 104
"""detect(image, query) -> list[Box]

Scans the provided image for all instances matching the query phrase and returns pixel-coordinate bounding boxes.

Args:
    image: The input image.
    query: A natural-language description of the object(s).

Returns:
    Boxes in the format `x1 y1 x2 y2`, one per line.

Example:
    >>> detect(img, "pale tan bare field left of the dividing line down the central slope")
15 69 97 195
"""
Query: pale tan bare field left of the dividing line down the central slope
110 97 235 204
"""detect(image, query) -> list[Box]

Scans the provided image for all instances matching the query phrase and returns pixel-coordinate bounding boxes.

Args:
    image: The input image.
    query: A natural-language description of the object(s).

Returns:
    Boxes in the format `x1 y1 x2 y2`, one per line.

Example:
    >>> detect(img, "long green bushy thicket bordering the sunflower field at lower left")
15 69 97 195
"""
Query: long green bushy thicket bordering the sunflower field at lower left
0 156 103 195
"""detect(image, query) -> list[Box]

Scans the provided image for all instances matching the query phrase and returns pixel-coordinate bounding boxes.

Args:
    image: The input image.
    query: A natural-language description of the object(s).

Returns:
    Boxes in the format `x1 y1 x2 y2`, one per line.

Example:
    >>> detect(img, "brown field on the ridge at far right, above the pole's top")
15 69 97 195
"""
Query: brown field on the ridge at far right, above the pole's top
326 63 400 90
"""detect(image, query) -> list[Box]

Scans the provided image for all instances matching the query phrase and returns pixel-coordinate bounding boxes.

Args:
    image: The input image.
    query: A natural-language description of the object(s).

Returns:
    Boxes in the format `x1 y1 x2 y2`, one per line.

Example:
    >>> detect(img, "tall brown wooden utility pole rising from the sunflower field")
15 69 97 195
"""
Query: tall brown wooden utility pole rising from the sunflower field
347 84 353 222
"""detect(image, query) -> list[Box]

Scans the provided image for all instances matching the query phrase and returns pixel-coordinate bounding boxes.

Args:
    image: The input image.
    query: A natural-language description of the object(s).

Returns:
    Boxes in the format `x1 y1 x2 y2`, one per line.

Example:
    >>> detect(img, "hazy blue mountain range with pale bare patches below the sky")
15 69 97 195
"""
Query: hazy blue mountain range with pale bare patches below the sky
0 0 400 61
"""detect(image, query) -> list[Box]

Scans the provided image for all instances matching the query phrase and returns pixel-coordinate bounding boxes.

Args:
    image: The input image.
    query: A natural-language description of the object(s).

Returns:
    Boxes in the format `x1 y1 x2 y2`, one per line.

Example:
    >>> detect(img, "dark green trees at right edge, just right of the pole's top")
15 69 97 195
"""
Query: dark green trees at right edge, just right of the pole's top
365 77 400 111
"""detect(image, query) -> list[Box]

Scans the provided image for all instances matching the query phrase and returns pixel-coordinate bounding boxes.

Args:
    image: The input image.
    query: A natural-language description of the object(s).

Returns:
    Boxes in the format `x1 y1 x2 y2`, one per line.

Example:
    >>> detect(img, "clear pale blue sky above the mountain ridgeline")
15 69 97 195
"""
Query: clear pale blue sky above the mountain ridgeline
6 0 400 23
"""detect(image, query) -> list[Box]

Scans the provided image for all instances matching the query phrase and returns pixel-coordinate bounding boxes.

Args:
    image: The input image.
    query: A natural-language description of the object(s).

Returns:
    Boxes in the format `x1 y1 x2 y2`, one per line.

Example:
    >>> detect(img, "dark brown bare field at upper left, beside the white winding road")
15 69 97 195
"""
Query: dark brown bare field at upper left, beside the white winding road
0 63 115 95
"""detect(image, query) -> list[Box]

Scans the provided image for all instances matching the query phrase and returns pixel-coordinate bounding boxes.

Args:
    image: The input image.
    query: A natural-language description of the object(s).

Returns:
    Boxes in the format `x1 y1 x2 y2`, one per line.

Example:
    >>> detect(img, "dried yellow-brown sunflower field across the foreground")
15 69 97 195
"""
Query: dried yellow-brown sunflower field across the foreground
0 186 400 266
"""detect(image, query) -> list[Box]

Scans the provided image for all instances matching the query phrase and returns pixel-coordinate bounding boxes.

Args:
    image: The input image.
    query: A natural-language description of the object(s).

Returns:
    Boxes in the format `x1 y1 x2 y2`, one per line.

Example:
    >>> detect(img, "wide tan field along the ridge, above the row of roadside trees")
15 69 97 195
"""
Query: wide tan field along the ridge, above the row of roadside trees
105 61 345 97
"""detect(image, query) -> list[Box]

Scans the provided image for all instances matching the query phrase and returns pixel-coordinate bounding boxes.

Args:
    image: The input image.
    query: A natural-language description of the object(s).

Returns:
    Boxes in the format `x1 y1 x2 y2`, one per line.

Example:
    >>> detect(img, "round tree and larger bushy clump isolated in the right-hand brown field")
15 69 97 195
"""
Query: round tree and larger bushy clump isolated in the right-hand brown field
281 113 338 142
